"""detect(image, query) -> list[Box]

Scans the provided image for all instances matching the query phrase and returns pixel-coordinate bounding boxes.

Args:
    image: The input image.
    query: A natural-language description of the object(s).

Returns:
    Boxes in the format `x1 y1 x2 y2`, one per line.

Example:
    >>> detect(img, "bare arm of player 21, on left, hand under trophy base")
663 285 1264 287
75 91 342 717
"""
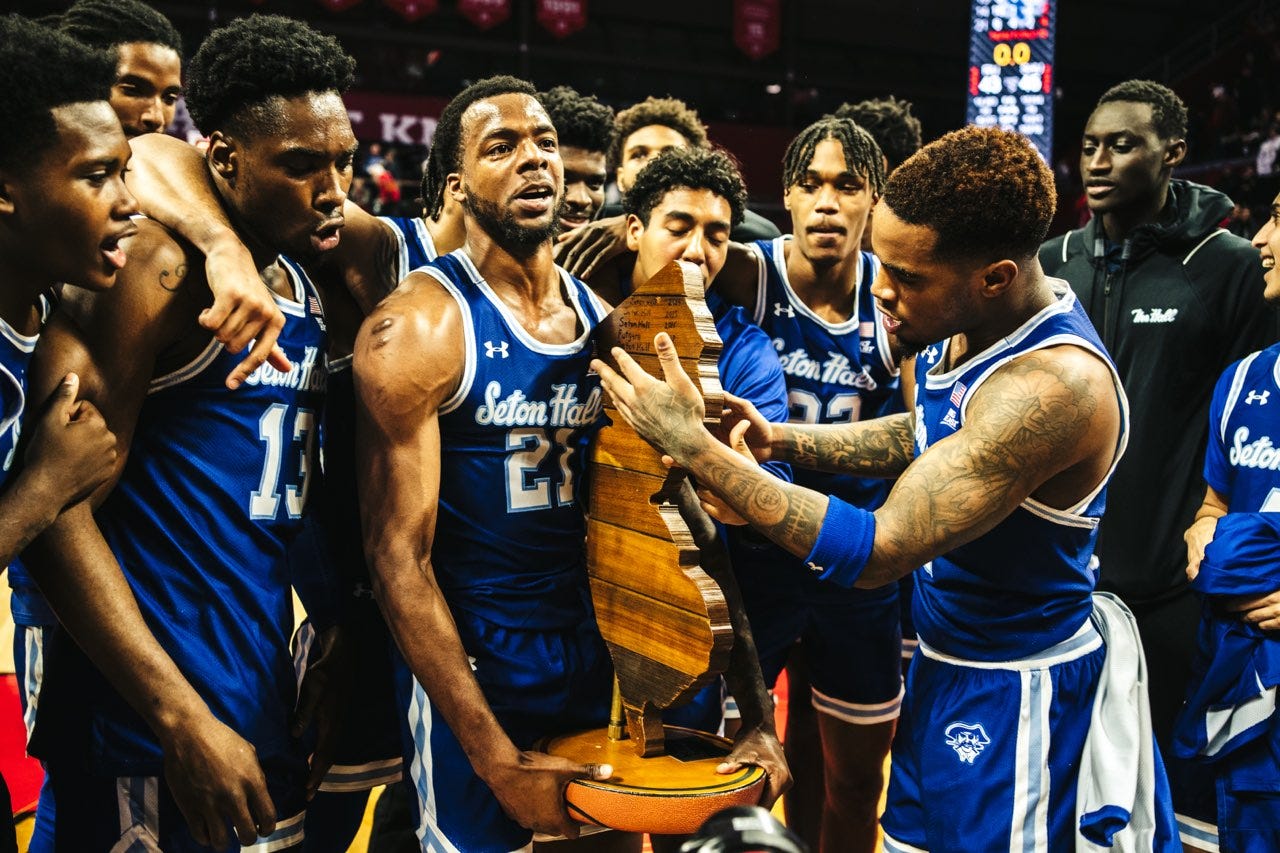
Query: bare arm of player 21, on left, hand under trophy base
355 273 612 838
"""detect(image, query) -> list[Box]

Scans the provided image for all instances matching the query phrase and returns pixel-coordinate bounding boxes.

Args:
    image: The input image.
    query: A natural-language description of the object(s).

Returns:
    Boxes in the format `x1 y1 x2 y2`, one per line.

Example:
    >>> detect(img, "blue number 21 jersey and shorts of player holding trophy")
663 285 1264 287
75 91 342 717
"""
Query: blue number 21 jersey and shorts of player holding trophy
406 250 612 853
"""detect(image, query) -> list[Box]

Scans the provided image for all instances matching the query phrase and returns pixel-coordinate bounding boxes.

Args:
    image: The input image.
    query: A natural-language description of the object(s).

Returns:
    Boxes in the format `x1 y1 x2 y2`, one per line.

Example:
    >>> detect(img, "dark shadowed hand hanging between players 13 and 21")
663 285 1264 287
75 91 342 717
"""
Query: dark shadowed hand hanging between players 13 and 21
293 625 356 800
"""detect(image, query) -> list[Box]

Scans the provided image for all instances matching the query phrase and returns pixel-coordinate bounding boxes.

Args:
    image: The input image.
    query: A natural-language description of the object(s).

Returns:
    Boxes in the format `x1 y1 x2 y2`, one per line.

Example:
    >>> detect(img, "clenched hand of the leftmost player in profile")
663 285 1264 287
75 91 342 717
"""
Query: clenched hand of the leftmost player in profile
22 373 116 508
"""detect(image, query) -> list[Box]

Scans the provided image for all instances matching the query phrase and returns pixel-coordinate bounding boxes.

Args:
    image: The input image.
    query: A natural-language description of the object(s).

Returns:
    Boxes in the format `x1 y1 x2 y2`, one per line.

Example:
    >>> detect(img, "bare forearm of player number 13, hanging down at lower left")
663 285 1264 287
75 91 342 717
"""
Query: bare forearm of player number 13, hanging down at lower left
23 503 209 742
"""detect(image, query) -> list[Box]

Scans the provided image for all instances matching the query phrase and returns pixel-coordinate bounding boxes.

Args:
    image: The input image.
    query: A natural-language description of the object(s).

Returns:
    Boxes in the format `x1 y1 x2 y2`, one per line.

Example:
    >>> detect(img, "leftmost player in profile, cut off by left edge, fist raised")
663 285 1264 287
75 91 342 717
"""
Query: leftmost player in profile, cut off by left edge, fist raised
0 15 128 852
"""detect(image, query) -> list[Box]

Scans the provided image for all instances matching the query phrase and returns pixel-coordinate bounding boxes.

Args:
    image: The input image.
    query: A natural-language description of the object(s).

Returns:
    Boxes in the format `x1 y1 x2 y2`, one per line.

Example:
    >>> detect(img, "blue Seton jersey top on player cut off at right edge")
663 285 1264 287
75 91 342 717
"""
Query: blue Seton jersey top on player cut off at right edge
1204 343 1280 512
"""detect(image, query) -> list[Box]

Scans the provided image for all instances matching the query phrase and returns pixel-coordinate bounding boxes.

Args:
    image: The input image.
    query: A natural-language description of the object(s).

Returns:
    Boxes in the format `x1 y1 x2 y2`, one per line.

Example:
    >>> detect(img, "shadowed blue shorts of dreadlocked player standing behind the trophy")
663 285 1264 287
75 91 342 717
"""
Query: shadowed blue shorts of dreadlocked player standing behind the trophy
730 530 902 725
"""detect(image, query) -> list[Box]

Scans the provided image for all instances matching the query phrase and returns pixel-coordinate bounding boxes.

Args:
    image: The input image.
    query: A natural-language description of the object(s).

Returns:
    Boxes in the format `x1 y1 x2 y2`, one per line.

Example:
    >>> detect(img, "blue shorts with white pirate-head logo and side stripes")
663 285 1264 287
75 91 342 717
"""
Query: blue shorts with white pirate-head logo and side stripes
881 621 1106 853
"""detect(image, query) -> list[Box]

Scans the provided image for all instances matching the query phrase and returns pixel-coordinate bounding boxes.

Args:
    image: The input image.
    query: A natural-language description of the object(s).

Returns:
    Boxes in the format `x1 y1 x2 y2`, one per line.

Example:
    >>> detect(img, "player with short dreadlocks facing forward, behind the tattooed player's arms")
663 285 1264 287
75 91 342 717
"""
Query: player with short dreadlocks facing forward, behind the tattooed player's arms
686 117 902 850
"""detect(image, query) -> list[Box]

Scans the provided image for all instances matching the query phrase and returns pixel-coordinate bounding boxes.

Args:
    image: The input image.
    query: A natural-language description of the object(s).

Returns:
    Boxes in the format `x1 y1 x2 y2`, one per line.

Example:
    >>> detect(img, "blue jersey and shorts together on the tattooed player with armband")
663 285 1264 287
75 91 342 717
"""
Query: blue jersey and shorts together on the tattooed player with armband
882 282 1175 852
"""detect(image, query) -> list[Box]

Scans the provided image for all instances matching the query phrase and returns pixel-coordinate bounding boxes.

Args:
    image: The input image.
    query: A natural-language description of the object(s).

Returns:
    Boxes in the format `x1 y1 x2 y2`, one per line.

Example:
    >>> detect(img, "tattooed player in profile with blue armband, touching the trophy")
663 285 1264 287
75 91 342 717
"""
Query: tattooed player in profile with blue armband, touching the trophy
594 128 1178 852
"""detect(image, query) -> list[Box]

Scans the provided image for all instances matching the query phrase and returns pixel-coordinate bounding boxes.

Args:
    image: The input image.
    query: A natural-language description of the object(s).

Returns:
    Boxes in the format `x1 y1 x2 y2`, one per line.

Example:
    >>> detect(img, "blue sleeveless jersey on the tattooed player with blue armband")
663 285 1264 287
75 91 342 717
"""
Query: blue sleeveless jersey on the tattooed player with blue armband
913 279 1129 661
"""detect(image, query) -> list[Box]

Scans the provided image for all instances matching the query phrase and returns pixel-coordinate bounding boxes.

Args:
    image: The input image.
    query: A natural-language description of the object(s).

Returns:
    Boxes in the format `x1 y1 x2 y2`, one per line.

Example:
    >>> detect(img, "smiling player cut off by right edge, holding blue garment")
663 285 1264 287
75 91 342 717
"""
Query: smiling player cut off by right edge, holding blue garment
1174 196 1280 853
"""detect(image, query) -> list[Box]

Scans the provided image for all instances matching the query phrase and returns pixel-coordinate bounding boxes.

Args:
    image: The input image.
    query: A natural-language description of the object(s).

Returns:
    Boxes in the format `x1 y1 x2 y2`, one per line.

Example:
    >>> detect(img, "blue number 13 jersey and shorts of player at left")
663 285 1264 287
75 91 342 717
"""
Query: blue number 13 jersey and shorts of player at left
31 259 326 849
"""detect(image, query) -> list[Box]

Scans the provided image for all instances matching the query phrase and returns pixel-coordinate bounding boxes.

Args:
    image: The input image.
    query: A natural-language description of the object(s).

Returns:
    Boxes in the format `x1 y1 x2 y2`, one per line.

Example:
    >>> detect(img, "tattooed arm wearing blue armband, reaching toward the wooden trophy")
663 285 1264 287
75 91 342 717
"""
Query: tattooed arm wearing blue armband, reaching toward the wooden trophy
593 334 1120 588
